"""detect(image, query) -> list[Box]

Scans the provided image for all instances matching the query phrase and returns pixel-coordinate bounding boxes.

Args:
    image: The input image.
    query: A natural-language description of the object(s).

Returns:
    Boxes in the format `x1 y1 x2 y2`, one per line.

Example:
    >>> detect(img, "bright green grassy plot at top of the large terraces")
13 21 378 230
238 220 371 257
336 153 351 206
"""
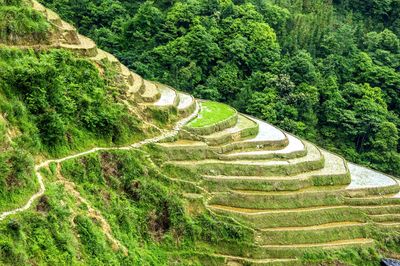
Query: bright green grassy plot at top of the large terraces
188 102 235 128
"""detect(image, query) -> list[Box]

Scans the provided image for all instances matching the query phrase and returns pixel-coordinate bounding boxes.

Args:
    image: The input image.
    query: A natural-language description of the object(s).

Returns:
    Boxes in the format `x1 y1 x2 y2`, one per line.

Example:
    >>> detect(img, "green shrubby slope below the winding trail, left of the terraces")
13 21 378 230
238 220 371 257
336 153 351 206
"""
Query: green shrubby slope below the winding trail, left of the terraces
0 151 251 265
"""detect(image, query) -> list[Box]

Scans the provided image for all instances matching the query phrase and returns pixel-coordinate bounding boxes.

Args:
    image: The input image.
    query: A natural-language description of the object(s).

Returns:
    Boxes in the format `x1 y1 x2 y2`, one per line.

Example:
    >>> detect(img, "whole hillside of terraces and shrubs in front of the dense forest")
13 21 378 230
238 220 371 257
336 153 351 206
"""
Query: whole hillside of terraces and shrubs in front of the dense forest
0 0 400 265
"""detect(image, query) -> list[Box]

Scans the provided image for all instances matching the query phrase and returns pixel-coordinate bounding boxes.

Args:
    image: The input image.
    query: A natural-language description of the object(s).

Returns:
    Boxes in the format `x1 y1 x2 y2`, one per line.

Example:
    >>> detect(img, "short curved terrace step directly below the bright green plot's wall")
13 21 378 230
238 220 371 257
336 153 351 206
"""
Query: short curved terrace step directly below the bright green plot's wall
199 114 258 145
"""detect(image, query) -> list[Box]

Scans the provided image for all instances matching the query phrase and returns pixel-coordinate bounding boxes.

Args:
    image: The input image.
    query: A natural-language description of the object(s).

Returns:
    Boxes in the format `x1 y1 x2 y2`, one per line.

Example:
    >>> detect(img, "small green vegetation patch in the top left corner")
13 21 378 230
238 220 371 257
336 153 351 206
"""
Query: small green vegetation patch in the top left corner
0 0 50 44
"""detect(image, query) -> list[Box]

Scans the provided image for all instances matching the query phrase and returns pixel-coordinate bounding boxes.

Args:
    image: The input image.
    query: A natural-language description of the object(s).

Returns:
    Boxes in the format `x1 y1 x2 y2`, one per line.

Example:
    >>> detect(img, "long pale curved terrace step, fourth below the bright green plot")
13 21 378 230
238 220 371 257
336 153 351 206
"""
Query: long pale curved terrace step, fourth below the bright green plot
165 142 324 176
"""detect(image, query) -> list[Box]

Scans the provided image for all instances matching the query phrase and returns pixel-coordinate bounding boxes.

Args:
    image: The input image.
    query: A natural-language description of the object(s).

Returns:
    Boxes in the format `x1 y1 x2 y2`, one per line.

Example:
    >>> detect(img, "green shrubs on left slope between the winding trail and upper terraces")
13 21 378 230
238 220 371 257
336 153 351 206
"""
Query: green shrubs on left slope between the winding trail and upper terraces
0 41 143 218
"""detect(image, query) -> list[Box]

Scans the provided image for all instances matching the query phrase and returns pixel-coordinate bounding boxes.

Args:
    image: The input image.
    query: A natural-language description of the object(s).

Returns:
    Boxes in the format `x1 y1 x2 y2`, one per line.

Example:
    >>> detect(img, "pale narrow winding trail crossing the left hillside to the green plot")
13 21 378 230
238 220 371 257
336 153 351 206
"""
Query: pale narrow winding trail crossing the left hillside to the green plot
0 101 200 221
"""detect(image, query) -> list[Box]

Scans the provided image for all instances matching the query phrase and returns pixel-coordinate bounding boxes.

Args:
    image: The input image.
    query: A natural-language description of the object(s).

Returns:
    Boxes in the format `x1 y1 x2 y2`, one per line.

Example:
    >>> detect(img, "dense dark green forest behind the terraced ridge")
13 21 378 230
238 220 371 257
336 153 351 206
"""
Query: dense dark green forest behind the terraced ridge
42 0 400 174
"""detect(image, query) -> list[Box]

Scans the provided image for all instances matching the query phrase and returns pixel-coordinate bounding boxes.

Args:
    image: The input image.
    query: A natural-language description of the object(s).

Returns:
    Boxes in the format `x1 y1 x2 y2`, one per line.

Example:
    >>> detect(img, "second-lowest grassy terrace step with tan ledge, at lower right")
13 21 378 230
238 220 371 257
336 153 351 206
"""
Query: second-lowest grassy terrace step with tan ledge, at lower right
255 221 369 245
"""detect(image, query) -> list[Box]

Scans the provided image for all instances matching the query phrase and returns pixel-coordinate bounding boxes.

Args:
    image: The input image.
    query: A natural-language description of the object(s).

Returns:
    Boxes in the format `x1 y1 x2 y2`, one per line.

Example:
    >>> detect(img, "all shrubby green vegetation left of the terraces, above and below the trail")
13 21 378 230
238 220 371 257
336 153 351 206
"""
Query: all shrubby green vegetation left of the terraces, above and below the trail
0 0 251 265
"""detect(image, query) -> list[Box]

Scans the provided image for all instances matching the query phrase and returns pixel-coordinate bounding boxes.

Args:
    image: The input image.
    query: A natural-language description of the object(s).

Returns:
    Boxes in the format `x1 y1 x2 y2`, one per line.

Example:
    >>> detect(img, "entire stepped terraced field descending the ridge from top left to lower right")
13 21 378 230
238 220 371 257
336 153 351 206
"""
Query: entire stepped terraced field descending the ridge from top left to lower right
5 1 400 265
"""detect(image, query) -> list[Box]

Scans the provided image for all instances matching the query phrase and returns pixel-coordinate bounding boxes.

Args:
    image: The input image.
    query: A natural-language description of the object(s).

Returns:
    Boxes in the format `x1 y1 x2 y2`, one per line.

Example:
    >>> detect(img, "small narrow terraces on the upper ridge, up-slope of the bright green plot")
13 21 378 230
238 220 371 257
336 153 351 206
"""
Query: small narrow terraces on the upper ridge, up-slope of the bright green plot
9 0 189 116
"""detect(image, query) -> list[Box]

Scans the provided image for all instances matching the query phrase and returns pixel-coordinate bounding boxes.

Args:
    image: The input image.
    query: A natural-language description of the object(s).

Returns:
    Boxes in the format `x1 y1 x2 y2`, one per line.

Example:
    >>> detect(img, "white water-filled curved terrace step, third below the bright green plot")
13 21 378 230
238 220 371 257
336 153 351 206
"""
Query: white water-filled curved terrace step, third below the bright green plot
220 134 307 160
